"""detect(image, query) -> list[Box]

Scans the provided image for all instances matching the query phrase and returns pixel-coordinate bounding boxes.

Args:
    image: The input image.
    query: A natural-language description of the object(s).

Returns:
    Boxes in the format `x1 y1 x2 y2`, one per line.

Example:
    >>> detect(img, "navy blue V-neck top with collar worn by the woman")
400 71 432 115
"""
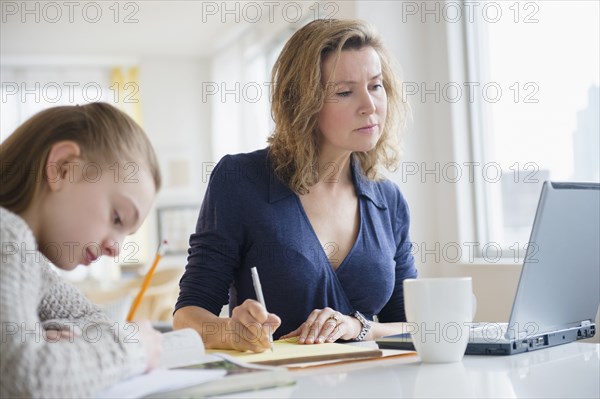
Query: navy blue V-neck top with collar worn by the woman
175 149 417 339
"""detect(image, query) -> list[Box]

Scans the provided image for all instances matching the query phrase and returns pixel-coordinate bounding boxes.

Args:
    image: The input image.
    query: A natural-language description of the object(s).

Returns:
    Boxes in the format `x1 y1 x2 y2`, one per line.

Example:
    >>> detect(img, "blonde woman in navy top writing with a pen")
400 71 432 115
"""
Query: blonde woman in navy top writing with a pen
174 20 416 351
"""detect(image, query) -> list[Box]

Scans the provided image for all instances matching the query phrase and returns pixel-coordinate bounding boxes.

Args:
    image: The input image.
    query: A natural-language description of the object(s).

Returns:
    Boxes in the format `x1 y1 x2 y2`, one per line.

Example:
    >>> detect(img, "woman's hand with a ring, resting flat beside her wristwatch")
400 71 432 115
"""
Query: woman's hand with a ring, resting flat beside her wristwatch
281 308 362 344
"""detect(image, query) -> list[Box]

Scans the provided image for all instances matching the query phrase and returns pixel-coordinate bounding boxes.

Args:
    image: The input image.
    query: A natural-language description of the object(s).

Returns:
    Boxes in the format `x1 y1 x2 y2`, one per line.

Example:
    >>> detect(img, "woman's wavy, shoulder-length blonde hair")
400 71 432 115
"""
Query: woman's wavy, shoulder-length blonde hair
268 19 410 194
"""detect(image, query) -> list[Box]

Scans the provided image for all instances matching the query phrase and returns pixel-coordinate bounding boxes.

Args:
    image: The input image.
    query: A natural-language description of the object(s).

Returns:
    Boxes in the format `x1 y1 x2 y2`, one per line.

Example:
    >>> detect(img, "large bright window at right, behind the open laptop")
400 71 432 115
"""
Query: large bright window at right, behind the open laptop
464 1 600 254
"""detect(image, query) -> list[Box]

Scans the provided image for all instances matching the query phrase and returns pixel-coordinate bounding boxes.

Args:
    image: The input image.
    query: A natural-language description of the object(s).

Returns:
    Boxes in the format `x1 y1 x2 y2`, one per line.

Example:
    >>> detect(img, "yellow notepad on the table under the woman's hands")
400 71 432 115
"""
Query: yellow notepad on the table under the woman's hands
207 339 382 366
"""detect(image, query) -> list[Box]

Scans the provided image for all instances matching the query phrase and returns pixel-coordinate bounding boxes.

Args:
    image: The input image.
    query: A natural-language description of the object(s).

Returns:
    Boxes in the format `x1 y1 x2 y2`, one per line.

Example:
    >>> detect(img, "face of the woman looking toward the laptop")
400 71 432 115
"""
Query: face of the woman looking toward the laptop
318 47 387 158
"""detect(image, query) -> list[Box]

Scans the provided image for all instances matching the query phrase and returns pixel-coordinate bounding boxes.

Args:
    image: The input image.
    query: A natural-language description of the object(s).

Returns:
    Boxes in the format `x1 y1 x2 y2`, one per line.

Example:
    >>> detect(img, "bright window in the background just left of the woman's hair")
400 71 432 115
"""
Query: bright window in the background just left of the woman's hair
210 25 294 160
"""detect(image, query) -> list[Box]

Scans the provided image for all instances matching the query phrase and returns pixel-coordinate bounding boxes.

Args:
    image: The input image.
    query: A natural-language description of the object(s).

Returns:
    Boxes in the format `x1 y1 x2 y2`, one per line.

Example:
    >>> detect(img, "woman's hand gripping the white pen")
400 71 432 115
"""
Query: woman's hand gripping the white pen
225 299 281 352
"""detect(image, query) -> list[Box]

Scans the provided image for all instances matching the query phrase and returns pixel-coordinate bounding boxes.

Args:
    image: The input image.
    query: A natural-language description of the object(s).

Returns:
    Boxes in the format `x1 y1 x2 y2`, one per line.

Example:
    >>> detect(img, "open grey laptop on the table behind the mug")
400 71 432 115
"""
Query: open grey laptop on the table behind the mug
376 181 600 355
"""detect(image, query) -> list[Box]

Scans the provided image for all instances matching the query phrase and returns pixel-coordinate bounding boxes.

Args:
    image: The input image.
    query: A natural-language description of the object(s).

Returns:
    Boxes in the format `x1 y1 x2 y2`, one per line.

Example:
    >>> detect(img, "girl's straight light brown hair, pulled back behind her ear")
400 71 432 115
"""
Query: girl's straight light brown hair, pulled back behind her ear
0 103 161 213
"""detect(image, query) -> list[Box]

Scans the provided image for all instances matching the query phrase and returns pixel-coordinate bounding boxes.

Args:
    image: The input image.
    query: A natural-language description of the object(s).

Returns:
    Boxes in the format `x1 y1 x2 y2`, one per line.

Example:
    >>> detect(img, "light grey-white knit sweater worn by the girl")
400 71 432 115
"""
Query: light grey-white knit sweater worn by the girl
0 207 146 398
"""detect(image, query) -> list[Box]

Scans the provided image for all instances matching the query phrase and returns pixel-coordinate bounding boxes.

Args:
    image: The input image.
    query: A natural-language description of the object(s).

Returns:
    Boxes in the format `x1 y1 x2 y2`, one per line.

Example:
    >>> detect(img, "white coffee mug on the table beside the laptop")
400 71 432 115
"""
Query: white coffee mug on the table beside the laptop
404 277 477 363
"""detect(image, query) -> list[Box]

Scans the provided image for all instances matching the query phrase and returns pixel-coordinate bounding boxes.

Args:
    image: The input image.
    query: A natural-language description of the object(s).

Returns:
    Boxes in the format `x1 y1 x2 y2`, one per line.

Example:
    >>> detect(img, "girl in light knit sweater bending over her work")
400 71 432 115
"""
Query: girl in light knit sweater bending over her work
0 103 161 397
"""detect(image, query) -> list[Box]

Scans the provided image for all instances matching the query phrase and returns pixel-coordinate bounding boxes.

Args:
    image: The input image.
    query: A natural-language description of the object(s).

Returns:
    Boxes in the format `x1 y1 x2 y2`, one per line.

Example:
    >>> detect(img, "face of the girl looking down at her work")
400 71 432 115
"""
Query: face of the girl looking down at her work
37 155 155 270
